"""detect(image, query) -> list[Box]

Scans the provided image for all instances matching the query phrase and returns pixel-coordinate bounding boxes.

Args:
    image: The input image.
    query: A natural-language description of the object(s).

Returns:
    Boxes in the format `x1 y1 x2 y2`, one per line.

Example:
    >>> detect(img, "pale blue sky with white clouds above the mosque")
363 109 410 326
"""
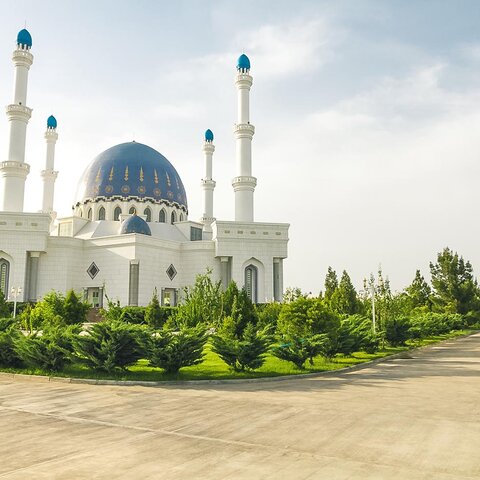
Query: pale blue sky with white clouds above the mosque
0 0 480 294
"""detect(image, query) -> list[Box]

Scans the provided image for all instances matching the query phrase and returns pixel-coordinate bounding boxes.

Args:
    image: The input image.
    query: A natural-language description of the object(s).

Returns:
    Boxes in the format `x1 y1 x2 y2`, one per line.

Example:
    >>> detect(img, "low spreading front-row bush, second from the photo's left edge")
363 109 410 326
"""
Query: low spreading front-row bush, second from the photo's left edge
14 326 80 372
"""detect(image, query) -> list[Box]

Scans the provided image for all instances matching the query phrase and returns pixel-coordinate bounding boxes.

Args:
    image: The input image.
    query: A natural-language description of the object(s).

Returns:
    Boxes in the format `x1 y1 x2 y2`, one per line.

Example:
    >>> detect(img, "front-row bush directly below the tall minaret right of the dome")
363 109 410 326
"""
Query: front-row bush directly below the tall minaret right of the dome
212 323 271 372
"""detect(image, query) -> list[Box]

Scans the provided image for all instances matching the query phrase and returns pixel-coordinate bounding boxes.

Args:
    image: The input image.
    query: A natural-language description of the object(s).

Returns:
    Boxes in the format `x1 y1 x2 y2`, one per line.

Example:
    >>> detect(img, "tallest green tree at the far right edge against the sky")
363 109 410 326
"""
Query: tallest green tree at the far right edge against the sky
430 247 478 314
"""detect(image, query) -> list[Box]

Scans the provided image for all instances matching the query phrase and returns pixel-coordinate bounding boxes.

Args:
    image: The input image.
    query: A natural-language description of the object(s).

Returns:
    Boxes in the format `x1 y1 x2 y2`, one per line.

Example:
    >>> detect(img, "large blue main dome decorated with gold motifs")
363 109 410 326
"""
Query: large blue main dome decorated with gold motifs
76 142 188 212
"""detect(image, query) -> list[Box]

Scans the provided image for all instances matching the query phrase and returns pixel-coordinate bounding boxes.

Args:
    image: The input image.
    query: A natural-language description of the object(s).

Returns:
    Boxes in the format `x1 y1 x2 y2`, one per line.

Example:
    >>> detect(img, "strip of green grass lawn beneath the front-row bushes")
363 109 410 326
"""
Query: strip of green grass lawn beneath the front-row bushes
0 330 473 381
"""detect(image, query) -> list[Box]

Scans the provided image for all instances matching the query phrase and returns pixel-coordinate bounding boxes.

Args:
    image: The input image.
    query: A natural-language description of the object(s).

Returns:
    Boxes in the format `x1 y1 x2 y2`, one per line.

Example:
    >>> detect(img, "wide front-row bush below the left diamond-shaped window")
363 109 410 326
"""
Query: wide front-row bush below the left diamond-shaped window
73 321 144 373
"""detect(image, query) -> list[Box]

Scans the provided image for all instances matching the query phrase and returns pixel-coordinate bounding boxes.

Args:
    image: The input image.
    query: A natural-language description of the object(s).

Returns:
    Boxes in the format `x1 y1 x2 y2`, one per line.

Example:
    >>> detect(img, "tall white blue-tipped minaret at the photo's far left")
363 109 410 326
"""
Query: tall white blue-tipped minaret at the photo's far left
0 30 33 212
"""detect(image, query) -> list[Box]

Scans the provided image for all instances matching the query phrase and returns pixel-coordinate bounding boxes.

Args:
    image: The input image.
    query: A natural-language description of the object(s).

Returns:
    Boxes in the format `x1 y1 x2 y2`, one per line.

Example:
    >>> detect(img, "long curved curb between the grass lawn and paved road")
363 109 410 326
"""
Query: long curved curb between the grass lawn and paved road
0 331 480 387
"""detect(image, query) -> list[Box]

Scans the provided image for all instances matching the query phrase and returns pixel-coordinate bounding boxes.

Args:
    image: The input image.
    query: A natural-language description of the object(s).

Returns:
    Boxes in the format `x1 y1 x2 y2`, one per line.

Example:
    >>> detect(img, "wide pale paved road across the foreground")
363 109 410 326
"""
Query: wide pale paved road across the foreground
0 334 480 480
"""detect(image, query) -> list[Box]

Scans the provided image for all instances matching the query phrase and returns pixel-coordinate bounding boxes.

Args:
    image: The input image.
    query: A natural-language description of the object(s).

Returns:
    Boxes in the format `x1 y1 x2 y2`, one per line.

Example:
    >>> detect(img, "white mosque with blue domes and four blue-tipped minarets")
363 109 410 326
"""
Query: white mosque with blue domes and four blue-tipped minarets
0 29 289 307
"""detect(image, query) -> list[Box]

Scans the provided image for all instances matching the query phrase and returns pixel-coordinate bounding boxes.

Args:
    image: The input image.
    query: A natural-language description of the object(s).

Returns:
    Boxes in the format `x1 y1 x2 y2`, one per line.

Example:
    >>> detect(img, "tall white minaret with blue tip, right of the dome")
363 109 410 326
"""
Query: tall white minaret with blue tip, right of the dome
232 54 257 222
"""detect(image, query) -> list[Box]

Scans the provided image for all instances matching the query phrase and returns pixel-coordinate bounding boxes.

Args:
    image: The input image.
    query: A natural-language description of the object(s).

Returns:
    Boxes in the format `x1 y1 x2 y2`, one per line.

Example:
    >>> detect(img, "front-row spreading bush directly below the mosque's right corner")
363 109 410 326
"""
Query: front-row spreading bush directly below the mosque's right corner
272 334 328 370
